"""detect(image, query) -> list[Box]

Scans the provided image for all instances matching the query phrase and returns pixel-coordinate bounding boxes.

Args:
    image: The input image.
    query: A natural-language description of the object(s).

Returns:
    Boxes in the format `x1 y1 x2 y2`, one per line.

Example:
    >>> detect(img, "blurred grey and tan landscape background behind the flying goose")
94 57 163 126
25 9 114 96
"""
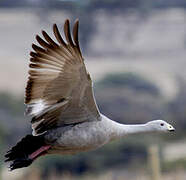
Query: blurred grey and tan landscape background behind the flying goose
0 0 186 180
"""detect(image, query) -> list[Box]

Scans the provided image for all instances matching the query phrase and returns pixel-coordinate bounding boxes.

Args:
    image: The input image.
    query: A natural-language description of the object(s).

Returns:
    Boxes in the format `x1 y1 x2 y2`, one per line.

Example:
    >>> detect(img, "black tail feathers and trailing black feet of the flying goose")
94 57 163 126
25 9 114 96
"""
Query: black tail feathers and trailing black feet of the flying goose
5 135 45 170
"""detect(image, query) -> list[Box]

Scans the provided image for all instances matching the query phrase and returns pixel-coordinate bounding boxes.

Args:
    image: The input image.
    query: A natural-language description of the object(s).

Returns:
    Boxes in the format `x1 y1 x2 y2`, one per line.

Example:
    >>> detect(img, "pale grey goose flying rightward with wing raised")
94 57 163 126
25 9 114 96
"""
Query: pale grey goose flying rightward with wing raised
5 20 174 170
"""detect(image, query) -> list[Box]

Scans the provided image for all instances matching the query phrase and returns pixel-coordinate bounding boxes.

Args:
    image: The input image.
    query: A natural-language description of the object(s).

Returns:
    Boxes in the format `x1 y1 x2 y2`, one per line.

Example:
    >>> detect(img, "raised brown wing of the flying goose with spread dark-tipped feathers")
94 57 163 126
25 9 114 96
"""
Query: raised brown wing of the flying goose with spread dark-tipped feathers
25 20 100 134
